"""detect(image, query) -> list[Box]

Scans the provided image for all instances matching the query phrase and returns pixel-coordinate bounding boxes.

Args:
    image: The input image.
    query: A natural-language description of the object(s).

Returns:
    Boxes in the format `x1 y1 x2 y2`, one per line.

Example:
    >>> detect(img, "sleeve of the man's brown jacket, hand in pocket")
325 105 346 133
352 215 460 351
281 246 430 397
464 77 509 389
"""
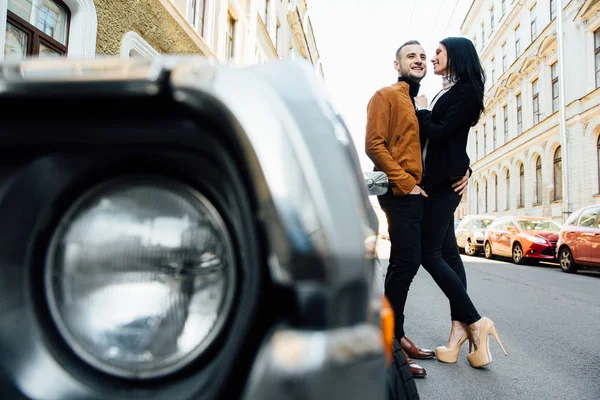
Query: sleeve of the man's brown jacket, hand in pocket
365 92 417 196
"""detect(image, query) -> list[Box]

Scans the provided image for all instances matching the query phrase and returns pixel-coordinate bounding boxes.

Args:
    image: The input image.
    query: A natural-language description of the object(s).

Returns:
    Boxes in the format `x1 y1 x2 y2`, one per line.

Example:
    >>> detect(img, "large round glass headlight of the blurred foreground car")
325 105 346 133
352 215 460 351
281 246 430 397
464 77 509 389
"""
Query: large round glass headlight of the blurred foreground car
45 180 236 378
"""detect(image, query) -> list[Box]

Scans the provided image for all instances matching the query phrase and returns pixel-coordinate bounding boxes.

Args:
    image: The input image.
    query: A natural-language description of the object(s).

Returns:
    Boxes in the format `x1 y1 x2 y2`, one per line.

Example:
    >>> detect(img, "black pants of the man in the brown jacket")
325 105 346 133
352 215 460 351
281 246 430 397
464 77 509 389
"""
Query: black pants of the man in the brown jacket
378 189 423 340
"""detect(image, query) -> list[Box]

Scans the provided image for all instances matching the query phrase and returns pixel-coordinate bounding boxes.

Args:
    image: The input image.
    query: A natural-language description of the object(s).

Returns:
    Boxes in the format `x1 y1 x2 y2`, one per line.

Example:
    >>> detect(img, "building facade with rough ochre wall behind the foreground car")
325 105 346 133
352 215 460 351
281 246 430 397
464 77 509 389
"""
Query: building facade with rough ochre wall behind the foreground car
0 0 323 75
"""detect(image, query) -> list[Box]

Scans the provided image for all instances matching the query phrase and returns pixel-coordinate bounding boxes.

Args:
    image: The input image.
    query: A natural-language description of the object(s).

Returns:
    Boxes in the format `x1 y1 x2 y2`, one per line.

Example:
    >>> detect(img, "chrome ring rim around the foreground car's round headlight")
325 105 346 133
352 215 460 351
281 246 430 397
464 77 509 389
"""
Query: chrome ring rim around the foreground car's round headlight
41 174 240 382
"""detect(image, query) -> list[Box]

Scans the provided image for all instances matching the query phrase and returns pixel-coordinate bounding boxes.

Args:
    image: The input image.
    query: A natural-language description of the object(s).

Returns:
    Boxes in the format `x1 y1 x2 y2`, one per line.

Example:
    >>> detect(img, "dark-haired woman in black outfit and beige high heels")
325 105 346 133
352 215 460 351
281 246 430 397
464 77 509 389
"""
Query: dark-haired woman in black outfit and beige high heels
415 37 506 368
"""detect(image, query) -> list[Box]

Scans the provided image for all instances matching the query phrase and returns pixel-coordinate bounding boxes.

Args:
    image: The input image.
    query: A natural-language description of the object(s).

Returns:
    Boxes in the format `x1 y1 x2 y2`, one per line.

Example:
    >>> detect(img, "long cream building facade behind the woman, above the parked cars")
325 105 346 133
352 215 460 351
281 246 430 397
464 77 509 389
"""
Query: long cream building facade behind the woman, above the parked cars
461 0 600 222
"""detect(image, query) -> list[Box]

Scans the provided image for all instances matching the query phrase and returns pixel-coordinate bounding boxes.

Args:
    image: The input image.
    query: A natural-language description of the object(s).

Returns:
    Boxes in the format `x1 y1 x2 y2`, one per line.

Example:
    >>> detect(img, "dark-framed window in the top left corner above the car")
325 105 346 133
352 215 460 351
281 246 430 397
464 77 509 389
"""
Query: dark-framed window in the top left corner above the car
4 0 71 61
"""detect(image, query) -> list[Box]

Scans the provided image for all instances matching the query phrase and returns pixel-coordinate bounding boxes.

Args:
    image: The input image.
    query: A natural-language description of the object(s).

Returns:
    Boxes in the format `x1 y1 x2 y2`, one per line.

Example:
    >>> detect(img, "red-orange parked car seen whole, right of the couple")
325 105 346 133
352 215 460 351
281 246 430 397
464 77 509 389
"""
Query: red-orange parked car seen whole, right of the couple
483 216 561 264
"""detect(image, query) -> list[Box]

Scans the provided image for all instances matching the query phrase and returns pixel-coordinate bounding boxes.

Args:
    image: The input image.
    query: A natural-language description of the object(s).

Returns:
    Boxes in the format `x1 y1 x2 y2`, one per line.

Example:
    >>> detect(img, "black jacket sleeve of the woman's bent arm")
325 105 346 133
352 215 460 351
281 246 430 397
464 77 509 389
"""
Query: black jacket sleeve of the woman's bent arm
417 83 479 142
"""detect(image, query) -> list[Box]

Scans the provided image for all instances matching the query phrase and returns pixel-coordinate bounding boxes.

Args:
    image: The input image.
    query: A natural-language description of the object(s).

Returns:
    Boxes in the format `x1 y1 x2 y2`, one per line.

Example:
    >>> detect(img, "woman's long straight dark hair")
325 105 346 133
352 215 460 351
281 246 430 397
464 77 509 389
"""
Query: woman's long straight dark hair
440 37 485 126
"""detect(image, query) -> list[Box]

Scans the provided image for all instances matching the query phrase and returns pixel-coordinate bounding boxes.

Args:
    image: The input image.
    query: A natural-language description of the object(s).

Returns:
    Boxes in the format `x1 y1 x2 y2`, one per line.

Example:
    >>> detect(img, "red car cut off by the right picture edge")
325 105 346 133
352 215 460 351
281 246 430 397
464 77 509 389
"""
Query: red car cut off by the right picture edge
556 205 600 273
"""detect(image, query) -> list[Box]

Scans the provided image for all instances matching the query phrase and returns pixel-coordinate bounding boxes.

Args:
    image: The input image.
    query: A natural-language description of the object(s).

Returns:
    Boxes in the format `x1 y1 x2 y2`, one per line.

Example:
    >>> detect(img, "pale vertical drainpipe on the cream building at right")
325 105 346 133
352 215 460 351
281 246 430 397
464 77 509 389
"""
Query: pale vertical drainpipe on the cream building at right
556 0 571 222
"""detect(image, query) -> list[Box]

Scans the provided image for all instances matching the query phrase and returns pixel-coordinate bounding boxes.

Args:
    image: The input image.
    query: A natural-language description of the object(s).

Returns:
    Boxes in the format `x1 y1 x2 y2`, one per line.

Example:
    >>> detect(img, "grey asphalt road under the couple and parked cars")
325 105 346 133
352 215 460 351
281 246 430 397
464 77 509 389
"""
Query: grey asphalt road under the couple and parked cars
379 244 600 400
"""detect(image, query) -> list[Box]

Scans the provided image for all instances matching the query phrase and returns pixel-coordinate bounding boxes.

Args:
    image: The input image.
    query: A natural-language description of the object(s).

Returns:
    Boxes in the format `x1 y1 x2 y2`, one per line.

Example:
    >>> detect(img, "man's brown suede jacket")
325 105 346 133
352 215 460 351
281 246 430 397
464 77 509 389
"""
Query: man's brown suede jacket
365 82 423 196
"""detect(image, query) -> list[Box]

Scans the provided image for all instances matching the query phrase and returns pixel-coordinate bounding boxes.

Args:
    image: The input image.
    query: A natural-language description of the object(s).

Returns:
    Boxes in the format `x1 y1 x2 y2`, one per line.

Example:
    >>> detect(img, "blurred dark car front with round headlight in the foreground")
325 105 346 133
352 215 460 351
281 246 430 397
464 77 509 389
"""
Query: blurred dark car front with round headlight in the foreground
0 57 416 400
